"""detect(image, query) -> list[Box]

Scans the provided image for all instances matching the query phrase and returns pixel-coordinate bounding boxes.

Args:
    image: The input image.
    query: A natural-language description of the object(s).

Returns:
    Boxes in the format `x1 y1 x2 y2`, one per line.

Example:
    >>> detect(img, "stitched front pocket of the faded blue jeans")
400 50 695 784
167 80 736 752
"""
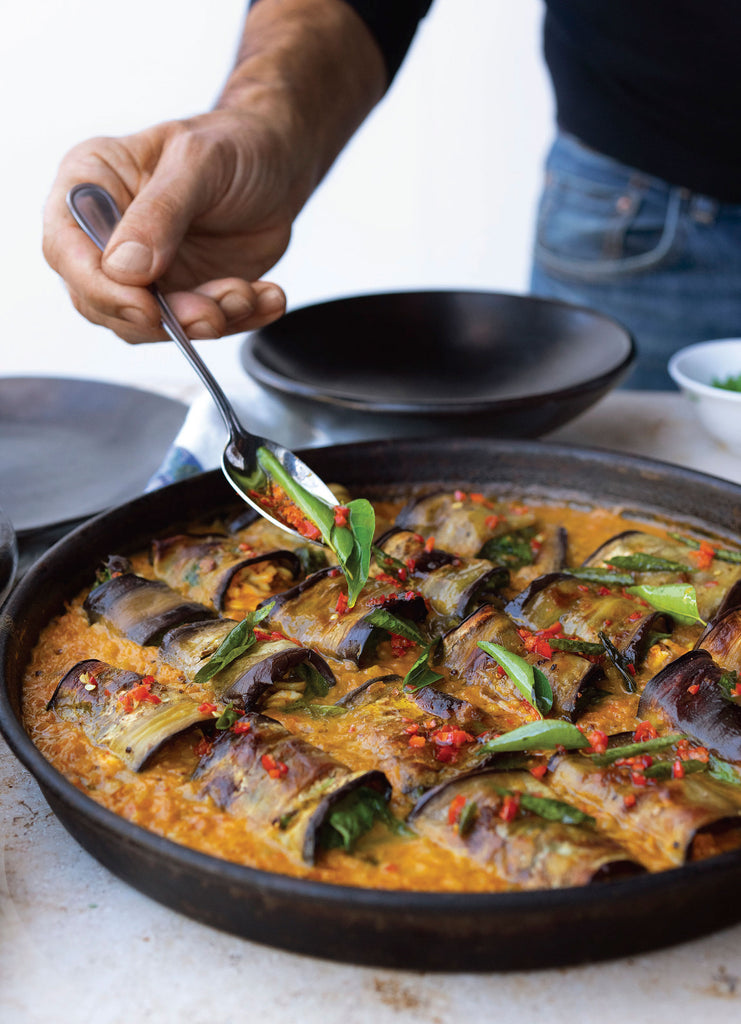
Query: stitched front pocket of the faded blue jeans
534 143 684 282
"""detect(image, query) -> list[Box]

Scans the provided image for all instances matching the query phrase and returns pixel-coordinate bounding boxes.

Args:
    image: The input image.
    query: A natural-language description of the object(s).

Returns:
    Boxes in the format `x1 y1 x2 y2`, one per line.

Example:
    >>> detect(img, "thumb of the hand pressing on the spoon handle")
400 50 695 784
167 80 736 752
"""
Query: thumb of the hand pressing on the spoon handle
102 148 208 285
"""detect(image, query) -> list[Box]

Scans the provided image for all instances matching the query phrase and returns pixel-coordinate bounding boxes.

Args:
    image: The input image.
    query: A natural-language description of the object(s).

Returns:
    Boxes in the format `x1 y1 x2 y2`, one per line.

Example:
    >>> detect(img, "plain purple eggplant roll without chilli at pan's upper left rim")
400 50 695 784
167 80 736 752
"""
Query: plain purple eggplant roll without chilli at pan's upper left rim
84 572 214 646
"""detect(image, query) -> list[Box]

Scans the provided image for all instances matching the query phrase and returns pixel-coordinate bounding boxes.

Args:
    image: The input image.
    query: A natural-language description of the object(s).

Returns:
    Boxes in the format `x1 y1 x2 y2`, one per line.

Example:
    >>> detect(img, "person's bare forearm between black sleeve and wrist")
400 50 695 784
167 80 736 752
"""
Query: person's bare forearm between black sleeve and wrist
217 0 387 212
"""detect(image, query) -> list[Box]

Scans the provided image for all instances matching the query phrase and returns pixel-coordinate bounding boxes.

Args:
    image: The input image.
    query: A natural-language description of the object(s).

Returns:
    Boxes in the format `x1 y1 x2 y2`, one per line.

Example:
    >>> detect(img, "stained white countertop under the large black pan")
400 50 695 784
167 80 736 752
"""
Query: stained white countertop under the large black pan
0 388 741 1024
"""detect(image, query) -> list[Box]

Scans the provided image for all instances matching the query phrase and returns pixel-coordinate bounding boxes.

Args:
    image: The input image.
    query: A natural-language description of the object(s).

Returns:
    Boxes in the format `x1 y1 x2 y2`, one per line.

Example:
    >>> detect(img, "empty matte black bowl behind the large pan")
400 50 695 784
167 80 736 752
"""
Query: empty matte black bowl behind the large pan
242 291 635 439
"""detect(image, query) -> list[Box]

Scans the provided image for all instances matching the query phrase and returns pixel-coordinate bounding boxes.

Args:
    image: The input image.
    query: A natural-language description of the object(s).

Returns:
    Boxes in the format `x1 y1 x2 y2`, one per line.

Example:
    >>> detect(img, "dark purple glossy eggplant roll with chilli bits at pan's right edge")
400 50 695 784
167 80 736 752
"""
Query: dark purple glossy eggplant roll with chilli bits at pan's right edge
638 650 741 763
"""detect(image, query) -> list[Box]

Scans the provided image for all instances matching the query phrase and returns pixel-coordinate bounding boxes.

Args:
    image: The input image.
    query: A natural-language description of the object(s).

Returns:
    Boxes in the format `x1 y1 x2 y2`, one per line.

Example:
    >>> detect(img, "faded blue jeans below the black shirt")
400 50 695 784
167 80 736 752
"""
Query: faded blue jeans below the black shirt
531 134 741 388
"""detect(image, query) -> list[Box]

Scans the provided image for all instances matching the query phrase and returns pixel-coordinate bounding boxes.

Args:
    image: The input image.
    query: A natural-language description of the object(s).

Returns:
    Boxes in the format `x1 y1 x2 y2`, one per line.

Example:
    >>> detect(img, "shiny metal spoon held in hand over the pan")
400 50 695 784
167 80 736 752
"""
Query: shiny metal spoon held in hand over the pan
67 184 338 536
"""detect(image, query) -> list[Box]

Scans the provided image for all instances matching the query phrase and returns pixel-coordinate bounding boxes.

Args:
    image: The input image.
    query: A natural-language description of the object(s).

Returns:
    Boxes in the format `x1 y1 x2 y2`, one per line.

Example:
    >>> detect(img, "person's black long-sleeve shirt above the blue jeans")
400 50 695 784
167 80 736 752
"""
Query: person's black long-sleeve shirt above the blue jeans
346 0 741 202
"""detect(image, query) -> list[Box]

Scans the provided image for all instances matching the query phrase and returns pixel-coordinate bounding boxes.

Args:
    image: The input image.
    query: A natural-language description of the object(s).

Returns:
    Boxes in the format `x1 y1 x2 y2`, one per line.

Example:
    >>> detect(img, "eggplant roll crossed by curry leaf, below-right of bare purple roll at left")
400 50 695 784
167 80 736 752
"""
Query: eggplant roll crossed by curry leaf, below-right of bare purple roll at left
158 618 336 711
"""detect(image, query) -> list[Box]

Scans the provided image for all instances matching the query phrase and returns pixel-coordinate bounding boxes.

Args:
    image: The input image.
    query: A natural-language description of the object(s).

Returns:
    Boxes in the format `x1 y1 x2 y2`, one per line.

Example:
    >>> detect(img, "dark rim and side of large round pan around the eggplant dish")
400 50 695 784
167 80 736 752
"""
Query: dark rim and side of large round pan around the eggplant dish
0 440 741 971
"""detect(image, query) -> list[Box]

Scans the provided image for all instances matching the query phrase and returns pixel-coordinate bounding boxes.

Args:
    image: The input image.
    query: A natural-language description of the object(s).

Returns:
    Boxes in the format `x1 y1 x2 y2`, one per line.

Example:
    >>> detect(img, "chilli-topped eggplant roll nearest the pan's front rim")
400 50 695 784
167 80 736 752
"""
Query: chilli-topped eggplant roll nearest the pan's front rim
407 771 643 889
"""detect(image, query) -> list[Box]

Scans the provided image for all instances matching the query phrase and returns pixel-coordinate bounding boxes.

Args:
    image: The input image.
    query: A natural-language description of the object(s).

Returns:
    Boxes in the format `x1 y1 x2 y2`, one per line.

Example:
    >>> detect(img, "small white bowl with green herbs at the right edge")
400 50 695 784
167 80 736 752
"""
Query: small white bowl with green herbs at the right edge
668 338 741 455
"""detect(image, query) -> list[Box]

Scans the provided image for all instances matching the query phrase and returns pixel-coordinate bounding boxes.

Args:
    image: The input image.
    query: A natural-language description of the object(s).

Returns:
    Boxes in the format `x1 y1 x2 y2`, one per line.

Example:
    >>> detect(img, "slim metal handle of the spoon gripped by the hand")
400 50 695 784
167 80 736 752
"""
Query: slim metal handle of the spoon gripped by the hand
67 183 241 441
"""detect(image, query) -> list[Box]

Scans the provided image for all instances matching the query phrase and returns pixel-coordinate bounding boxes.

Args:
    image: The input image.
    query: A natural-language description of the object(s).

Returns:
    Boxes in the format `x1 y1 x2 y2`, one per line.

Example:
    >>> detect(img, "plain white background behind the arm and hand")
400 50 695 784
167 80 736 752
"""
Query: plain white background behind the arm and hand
0 0 552 393
